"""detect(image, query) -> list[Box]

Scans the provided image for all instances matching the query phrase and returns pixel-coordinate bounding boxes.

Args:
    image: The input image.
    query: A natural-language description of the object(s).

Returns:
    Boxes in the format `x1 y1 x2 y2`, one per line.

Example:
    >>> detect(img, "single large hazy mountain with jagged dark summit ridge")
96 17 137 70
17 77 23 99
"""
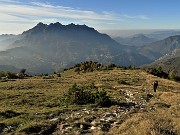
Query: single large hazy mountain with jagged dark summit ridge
0 23 151 73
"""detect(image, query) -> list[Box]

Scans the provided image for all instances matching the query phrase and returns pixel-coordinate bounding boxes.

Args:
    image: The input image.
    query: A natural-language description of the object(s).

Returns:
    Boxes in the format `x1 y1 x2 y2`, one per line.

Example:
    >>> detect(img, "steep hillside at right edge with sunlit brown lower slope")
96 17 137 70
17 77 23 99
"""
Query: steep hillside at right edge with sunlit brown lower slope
140 35 180 76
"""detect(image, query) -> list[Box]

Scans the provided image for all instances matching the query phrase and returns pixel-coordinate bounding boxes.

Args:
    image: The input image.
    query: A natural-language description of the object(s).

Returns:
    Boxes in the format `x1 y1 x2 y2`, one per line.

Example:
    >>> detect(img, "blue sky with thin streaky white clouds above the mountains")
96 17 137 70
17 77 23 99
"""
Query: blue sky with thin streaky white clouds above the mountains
0 0 180 34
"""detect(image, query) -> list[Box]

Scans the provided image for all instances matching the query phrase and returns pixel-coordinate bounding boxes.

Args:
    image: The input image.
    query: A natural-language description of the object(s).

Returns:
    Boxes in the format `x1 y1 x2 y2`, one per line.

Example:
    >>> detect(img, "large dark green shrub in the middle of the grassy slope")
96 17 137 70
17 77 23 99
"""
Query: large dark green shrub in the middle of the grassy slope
66 83 111 107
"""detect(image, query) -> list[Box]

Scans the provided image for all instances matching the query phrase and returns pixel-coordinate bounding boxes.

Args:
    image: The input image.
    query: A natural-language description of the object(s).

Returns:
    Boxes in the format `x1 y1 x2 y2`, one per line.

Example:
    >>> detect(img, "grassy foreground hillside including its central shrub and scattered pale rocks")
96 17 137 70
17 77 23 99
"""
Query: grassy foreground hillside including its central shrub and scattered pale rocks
0 66 180 135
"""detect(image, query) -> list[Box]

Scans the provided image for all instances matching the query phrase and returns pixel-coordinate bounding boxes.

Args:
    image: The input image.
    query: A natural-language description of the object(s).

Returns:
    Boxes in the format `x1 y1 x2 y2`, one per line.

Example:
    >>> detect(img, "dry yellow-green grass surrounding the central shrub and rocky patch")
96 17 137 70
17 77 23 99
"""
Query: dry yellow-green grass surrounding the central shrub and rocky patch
0 69 180 135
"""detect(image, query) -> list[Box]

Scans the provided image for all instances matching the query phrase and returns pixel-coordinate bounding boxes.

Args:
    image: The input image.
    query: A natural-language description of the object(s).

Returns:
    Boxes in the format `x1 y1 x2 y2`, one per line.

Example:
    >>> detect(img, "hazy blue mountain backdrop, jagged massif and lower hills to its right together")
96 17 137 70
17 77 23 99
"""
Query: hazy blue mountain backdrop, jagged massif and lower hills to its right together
0 22 180 74
